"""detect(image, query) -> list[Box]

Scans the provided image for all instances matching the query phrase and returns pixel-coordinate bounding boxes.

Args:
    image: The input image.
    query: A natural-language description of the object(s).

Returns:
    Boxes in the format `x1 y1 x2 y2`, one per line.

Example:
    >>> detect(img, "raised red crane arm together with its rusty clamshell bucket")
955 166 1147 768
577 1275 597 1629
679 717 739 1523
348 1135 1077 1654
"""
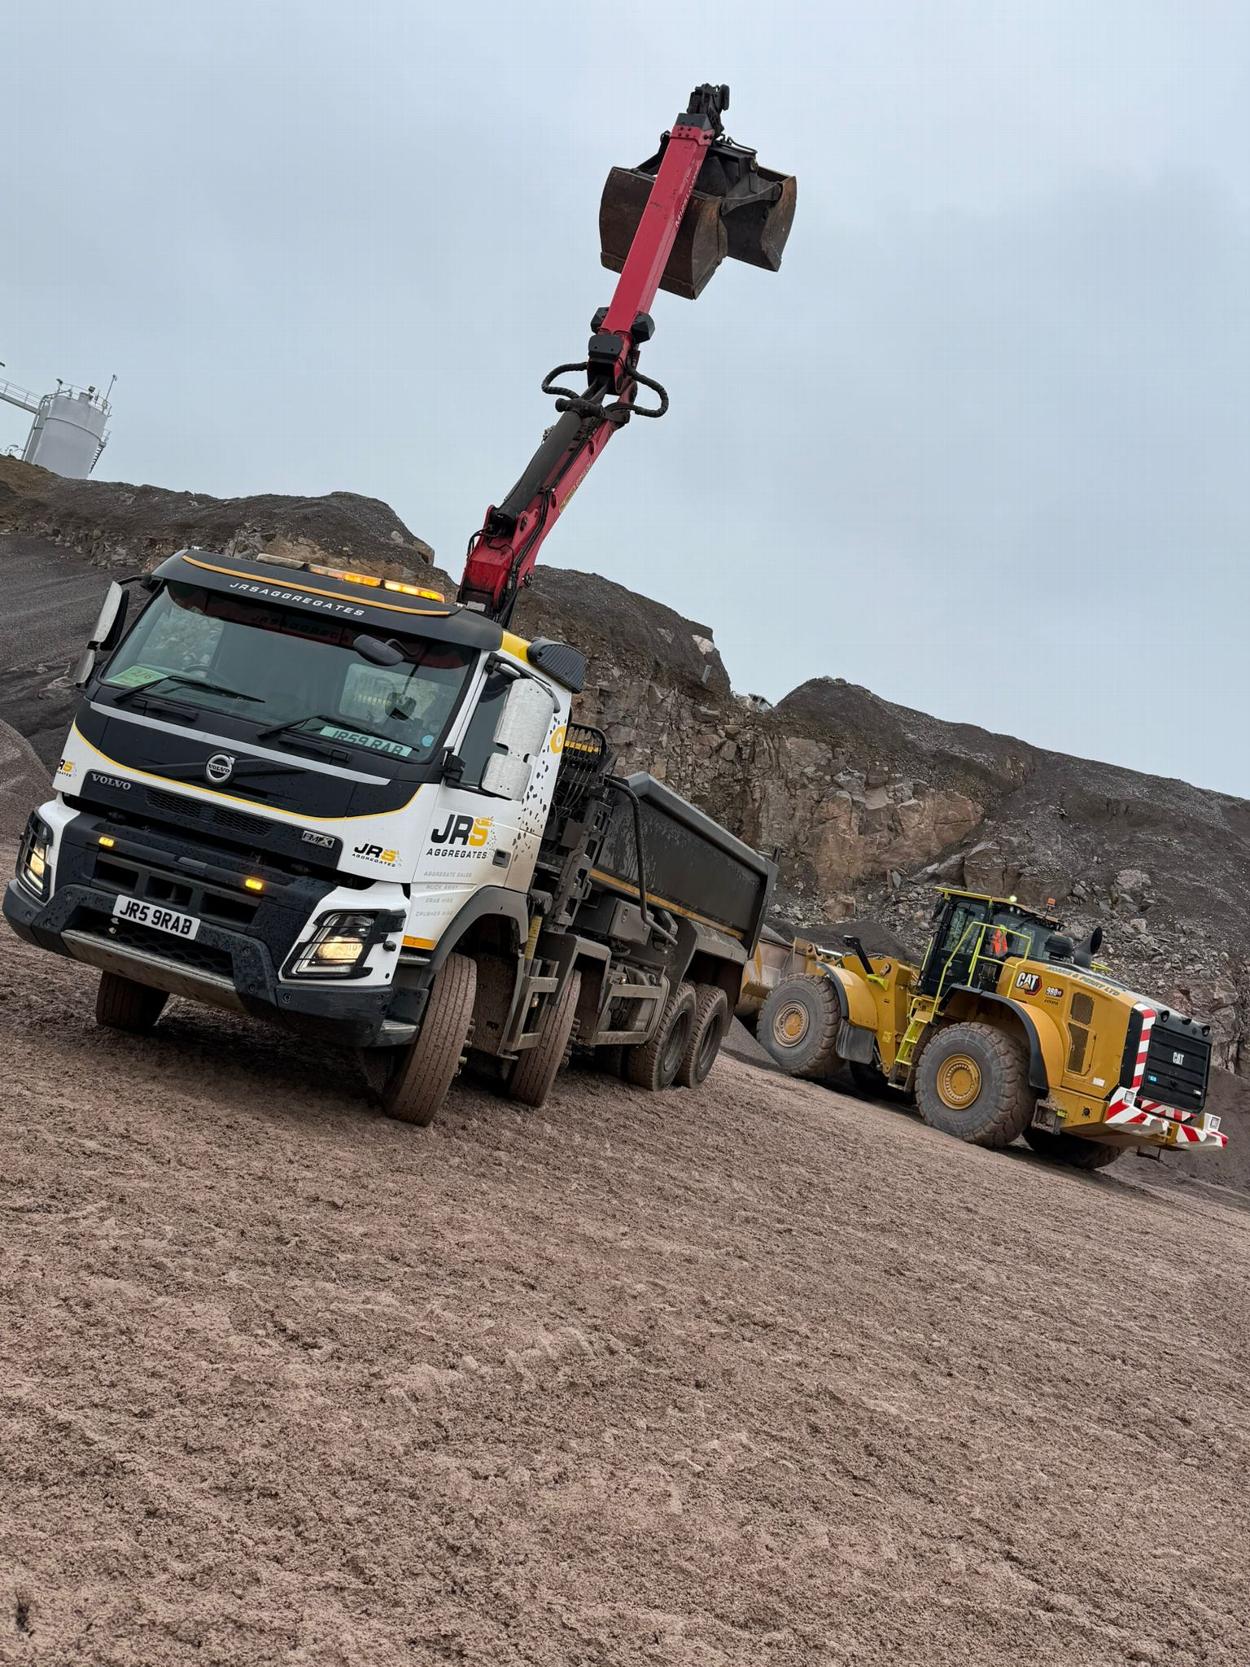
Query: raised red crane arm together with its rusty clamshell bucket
460 83 795 625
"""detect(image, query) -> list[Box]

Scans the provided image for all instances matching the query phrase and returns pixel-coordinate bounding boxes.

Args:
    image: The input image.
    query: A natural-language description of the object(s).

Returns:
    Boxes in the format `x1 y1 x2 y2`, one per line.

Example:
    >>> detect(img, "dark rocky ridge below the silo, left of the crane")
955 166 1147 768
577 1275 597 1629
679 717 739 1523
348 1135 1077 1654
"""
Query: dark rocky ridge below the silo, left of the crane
0 457 433 577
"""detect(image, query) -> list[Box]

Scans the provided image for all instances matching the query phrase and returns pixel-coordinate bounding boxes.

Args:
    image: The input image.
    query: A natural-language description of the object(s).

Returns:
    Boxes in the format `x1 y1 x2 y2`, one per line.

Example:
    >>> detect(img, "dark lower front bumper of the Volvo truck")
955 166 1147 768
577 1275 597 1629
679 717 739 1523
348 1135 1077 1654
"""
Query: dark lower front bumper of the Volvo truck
3 880 418 1047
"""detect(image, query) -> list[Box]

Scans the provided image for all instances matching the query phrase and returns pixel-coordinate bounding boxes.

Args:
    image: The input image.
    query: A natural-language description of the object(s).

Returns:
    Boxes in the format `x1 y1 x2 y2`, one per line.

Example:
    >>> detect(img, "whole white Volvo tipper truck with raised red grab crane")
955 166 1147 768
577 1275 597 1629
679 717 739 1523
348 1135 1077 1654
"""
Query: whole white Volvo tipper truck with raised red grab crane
3 87 793 1124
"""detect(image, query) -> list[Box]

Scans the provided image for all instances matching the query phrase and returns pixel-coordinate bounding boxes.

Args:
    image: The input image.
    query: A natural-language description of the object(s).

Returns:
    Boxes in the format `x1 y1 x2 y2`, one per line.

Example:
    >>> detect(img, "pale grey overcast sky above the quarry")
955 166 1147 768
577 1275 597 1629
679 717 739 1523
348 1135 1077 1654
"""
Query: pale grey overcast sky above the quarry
0 0 1250 795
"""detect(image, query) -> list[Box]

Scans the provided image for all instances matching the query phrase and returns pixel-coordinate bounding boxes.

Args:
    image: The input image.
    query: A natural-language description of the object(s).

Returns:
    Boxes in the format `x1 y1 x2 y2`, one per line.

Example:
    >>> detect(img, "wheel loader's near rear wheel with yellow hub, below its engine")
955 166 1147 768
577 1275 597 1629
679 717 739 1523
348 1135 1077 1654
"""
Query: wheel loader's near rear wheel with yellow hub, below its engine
915 1022 1037 1147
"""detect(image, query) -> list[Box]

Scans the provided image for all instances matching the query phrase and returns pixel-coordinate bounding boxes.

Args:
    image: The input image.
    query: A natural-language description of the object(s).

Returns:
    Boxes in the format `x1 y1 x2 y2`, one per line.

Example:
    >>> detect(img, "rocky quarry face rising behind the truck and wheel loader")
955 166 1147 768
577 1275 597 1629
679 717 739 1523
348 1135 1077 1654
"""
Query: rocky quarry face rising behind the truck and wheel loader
0 460 1250 1077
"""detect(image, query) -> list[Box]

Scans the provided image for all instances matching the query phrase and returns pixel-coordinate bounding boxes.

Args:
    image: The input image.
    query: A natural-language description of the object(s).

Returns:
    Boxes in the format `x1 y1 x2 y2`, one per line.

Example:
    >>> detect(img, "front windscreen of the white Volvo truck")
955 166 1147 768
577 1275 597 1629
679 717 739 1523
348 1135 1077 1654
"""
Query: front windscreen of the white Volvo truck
103 583 475 763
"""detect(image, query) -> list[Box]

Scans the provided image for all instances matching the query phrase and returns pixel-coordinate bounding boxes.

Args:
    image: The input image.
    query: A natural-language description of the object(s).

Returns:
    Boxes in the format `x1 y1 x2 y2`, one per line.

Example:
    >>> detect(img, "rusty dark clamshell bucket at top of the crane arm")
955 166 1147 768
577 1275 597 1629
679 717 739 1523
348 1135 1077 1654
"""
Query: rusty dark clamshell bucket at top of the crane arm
598 138 797 300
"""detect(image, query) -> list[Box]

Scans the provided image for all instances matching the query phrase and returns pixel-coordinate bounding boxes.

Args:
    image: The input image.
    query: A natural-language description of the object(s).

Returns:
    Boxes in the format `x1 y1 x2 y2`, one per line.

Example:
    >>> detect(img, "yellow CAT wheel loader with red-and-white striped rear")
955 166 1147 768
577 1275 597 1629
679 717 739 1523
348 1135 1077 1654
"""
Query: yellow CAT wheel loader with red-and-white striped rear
738 887 1228 1169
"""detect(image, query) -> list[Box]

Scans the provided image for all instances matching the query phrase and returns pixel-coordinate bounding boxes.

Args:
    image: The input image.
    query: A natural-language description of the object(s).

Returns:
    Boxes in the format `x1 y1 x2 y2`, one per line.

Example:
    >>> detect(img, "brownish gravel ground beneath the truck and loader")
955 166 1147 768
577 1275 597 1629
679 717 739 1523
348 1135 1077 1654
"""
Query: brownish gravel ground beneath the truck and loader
0 900 1250 1667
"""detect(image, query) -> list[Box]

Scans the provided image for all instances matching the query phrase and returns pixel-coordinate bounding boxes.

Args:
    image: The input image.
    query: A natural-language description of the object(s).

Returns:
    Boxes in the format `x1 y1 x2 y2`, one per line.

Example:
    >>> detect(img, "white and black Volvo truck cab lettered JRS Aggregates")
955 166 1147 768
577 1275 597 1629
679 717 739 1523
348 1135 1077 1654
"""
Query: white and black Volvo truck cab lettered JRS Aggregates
5 550 582 1047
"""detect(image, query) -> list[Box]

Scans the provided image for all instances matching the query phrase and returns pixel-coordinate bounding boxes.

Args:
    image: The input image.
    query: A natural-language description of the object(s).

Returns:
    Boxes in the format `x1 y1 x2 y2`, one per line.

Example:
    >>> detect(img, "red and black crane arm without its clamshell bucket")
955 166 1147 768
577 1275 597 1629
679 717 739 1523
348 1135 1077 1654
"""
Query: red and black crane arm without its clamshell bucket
458 87 728 625
